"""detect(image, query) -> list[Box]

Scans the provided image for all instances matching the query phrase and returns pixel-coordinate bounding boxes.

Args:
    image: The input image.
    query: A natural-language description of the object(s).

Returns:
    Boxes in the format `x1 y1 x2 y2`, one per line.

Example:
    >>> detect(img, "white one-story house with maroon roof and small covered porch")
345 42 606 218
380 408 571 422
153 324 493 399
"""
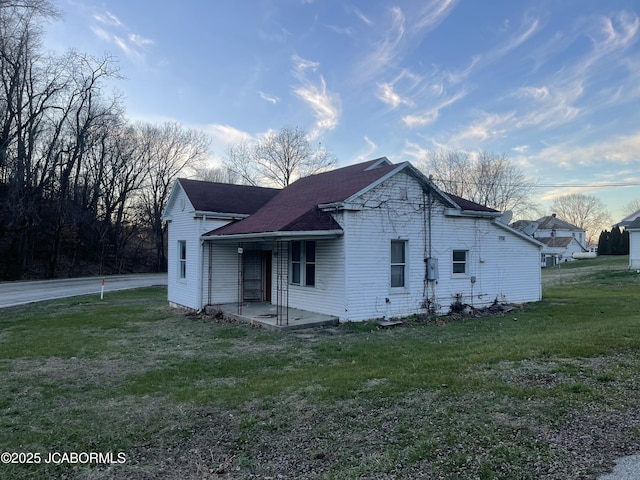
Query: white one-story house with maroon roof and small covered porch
165 158 542 321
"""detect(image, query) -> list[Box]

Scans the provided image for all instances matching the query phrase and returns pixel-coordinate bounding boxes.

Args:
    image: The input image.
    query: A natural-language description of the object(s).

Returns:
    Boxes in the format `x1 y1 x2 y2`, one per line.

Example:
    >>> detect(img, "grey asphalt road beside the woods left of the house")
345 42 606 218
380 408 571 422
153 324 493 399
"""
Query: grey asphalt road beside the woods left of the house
0 273 167 308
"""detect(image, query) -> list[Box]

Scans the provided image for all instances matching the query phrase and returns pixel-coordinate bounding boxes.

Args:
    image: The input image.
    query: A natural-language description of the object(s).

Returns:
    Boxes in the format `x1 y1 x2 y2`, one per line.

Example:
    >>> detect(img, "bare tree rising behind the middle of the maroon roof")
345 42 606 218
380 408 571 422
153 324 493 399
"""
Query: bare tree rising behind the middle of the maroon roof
225 127 336 187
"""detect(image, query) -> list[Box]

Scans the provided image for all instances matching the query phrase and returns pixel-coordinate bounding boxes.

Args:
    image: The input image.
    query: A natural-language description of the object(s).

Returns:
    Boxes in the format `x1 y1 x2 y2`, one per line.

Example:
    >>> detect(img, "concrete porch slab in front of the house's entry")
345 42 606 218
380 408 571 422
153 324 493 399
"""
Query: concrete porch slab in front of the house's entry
208 302 339 331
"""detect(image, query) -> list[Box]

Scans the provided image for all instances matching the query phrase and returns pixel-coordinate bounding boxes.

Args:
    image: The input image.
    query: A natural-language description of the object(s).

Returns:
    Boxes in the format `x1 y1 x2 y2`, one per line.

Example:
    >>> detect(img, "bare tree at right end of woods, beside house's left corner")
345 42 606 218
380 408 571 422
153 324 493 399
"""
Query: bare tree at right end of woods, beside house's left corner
139 122 209 271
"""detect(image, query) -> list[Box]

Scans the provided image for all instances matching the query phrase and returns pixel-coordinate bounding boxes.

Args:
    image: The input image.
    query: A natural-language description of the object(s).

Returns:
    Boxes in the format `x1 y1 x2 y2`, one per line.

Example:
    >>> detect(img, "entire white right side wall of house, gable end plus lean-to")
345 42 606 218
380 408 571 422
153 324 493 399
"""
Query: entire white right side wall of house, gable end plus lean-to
340 173 541 321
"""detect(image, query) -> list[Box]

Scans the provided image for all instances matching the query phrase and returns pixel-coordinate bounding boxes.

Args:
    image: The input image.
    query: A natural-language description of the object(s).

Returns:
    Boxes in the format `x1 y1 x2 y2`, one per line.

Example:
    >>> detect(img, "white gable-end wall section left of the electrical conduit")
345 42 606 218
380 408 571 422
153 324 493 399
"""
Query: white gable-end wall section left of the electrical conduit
341 173 426 321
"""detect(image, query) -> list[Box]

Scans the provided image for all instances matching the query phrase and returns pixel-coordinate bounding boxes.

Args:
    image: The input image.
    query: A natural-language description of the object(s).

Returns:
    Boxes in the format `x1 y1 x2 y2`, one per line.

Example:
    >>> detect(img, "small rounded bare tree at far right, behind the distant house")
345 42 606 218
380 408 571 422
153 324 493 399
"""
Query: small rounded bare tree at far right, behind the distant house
551 193 611 244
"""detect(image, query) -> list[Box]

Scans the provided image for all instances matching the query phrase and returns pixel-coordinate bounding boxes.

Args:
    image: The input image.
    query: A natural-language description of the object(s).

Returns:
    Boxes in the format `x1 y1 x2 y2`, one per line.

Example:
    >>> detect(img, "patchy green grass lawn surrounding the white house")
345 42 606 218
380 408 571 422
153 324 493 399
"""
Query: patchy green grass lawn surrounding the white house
0 257 640 479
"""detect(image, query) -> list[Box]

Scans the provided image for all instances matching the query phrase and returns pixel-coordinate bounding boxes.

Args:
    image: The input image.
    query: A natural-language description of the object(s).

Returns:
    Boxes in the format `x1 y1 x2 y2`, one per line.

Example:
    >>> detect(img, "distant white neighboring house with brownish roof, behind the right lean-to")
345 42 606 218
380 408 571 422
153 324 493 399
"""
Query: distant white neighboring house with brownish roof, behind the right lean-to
511 213 588 267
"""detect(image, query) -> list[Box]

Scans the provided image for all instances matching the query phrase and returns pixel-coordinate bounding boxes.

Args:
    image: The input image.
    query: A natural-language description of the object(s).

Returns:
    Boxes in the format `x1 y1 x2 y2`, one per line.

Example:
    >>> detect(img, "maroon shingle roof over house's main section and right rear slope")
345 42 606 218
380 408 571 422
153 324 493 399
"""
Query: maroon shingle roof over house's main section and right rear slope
206 157 496 236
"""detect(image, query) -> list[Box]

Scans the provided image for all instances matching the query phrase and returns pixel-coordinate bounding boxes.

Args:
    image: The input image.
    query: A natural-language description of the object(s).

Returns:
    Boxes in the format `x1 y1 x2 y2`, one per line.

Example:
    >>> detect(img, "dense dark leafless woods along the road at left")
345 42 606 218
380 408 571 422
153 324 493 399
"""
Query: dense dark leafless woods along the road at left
0 0 208 280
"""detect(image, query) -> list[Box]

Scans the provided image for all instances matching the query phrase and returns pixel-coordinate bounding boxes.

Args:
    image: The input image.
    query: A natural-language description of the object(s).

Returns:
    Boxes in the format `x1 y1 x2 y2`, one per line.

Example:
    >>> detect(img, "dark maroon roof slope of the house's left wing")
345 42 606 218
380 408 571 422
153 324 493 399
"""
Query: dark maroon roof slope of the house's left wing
178 178 280 215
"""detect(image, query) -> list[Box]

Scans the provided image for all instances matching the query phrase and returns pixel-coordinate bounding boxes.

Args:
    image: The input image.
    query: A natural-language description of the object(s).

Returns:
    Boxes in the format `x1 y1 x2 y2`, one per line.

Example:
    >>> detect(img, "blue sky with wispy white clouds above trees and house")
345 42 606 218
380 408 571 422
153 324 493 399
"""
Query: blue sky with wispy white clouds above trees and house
46 0 640 221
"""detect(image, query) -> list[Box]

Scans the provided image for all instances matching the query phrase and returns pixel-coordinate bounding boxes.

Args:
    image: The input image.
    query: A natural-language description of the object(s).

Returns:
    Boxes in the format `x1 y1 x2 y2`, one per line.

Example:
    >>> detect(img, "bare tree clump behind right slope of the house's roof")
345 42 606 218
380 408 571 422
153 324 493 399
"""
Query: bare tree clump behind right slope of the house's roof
418 150 535 215
